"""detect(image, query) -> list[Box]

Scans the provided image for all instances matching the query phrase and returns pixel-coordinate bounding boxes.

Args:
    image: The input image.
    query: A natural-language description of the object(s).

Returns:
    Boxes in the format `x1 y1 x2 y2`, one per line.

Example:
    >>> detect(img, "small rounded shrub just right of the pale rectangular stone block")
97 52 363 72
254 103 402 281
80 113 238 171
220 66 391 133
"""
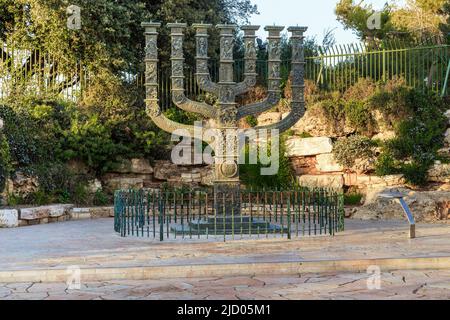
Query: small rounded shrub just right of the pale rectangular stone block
333 135 375 168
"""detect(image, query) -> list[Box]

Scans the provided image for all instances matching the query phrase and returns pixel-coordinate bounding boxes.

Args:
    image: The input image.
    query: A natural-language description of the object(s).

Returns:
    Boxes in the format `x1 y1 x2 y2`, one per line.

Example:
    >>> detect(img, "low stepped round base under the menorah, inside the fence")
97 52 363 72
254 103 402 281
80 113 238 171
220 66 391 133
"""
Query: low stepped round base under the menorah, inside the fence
171 216 287 235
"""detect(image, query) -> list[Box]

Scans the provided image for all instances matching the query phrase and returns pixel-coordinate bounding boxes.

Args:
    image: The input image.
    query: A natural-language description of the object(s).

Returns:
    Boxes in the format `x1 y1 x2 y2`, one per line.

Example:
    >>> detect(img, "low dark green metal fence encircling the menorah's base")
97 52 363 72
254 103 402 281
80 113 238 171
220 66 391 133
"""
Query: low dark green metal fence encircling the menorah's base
114 187 344 241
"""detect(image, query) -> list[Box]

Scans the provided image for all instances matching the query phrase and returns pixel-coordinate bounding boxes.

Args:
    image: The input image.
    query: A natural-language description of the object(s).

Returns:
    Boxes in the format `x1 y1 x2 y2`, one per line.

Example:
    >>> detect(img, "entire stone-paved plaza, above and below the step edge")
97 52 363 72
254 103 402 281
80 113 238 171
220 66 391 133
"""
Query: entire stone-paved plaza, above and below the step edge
0 219 450 300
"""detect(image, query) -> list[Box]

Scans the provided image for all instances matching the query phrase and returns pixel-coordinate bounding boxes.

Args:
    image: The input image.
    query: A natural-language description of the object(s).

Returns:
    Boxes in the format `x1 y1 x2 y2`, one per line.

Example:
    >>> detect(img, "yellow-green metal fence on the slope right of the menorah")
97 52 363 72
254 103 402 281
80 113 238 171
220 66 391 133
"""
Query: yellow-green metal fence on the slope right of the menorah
306 41 450 95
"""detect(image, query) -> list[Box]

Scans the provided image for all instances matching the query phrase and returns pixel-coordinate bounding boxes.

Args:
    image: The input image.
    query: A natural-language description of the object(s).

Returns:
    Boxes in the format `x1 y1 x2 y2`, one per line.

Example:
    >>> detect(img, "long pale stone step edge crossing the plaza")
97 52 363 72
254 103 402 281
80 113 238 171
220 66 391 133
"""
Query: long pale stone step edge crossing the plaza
0 256 450 283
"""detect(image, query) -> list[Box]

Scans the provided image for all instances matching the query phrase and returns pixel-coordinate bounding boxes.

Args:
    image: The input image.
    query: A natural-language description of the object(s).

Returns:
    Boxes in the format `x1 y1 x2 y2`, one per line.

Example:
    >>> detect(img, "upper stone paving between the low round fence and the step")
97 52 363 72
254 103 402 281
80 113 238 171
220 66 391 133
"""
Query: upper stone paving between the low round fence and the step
0 219 450 271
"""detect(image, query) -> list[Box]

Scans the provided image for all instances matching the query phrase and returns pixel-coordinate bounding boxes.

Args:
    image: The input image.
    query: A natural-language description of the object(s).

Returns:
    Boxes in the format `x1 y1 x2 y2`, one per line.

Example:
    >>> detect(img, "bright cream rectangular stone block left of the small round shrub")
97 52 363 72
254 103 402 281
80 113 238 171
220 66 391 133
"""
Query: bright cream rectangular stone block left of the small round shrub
286 137 333 157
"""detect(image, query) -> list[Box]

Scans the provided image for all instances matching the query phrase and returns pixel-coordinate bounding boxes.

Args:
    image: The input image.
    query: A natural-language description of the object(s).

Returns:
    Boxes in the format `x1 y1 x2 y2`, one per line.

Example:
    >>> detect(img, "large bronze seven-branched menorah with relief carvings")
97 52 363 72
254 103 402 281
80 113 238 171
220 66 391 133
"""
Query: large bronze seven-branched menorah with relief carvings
142 22 307 212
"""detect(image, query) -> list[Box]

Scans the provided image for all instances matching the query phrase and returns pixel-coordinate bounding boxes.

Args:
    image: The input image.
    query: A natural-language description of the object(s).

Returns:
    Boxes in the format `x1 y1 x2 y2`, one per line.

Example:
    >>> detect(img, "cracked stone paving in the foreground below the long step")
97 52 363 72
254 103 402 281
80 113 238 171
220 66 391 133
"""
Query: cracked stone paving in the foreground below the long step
0 270 450 300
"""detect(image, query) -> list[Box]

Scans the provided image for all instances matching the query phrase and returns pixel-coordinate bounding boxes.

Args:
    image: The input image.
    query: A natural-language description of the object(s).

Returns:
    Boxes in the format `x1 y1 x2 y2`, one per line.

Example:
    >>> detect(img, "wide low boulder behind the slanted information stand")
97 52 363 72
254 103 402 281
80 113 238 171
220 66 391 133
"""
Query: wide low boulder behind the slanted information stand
352 188 450 222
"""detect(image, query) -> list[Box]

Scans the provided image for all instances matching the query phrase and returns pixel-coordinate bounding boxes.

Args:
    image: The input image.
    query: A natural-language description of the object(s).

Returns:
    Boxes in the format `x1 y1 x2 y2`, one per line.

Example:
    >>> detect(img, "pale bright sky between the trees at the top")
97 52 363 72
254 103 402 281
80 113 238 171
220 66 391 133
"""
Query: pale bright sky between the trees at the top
250 0 404 44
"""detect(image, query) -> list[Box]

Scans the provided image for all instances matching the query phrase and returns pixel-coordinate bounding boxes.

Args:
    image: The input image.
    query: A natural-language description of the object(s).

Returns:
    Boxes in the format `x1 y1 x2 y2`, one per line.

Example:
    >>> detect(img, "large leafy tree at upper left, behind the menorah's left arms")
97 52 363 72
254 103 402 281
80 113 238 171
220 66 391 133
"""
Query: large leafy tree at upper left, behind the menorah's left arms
0 0 257 75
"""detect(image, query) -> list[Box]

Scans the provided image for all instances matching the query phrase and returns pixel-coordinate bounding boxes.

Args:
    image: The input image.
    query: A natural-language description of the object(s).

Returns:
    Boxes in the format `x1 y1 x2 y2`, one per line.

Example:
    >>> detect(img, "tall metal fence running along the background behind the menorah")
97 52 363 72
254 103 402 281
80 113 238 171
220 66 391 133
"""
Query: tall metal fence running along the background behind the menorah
0 42 450 109
